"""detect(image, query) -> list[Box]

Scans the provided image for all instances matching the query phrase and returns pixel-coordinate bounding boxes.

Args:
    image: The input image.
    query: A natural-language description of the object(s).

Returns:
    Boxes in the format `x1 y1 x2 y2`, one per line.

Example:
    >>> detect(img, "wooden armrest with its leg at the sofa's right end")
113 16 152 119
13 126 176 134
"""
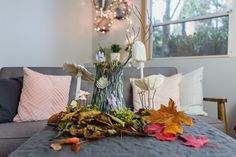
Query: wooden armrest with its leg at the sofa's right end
203 98 228 133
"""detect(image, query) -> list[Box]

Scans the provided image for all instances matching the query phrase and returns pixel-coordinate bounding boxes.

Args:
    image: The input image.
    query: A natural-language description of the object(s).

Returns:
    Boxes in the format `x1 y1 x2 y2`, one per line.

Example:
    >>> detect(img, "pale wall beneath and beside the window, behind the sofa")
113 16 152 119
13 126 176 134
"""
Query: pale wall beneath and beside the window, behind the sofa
93 1 236 137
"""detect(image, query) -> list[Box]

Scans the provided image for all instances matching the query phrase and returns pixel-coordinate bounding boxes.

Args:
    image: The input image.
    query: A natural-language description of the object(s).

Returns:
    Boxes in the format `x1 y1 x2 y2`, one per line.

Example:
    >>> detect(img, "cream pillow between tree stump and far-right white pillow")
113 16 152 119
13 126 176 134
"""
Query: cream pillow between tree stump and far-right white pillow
130 74 182 112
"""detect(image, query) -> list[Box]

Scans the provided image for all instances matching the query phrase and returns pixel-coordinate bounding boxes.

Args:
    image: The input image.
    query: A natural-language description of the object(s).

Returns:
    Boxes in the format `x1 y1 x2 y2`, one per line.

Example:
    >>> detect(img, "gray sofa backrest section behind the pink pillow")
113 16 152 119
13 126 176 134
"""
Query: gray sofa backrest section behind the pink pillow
0 67 77 102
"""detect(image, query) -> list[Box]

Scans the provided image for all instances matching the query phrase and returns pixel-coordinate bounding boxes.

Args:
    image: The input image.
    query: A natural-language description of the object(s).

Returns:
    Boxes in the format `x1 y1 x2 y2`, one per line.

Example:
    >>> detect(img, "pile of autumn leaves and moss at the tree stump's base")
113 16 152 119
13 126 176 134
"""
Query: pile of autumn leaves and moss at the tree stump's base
48 99 208 152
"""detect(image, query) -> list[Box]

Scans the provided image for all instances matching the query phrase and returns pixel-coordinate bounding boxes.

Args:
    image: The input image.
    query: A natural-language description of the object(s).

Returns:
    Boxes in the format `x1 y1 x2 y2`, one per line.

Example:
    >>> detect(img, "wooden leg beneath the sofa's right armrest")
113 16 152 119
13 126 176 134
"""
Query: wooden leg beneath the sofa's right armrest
217 101 228 134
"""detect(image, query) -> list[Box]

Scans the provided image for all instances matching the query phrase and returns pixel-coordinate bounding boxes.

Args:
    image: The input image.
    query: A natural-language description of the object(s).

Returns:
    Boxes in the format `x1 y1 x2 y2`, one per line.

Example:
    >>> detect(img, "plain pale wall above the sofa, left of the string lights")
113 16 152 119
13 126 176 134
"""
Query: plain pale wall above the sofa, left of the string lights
0 0 92 67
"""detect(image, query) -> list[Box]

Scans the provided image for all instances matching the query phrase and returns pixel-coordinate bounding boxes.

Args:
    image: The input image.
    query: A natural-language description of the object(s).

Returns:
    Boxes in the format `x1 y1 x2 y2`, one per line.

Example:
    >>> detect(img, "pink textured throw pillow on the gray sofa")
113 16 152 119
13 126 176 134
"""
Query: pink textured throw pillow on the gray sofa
13 68 71 122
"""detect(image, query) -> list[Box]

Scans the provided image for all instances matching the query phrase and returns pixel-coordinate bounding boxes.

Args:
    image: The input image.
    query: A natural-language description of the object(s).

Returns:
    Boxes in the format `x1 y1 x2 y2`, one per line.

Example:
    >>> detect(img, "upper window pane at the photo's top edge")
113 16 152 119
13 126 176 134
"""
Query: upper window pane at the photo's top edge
151 0 233 23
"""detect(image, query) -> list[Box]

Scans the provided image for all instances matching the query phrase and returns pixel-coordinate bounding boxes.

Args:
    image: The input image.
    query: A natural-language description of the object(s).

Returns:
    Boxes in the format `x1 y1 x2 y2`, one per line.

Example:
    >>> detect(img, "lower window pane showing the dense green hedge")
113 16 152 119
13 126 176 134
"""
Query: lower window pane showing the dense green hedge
152 16 229 58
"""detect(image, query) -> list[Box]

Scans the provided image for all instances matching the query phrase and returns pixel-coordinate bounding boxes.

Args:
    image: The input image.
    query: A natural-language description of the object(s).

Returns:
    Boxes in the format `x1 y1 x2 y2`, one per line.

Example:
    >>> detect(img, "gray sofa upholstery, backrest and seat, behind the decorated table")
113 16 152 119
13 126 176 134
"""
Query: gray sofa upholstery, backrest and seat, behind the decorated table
0 67 224 157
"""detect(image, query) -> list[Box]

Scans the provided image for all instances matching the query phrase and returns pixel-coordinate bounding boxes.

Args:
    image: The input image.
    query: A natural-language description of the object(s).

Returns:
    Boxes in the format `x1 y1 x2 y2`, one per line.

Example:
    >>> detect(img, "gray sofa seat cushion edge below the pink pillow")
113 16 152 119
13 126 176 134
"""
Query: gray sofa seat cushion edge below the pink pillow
0 120 47 140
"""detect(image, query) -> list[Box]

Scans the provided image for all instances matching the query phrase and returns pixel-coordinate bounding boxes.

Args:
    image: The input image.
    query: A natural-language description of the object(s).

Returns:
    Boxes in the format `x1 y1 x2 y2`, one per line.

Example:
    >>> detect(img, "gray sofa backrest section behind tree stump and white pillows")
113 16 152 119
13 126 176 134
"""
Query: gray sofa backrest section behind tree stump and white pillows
81 67 177 109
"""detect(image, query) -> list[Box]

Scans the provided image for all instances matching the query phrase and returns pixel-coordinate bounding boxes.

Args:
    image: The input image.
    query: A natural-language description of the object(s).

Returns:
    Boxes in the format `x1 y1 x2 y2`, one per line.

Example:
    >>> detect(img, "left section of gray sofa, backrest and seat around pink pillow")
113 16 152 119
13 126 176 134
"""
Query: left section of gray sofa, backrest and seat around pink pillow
0 67 77 157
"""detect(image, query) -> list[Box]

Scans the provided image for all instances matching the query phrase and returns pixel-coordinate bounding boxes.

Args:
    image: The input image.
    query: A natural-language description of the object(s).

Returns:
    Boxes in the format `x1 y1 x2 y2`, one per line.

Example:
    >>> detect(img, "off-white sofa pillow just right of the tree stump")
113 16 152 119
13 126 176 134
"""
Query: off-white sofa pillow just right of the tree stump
130 74 182 112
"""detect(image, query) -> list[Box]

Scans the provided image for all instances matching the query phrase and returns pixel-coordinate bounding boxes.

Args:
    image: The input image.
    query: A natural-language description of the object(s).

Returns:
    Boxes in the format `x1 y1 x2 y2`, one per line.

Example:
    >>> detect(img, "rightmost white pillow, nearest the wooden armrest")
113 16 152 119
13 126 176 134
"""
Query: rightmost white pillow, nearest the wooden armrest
180 67 207 116
